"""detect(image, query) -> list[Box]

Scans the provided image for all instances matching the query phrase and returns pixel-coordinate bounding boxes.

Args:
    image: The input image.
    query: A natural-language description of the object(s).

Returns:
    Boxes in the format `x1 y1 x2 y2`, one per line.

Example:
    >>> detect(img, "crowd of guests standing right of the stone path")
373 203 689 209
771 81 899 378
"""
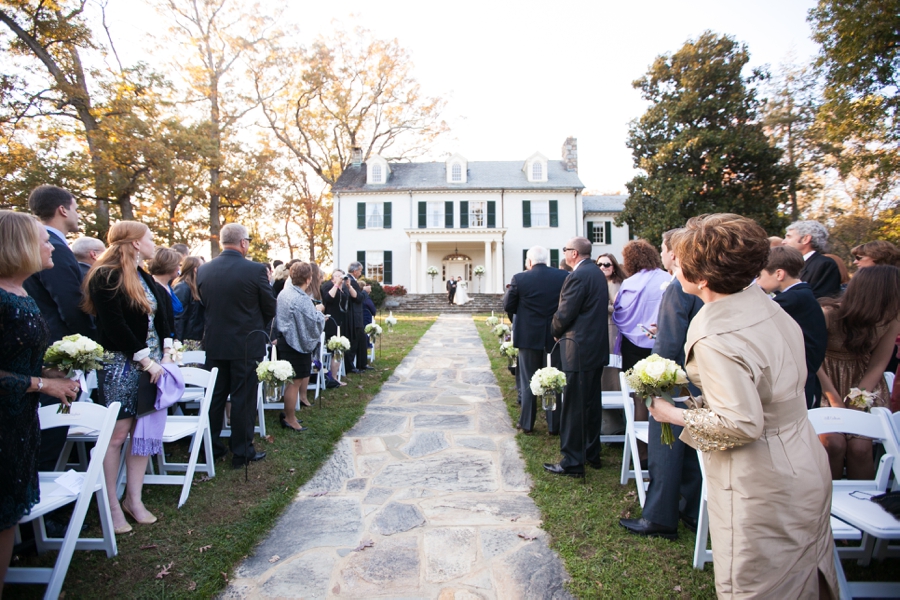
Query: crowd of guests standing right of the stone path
504 214 900 598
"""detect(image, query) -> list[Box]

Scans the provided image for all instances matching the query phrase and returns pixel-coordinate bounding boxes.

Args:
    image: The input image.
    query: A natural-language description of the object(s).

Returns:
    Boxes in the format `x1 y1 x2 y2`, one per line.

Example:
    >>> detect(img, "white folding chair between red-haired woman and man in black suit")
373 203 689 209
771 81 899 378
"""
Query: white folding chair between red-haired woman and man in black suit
144 367 219 508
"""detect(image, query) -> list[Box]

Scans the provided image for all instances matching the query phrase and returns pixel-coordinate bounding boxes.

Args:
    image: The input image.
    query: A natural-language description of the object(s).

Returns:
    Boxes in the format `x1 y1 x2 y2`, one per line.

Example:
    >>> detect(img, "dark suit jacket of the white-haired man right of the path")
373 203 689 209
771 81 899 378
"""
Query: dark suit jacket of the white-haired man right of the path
503 264 568 353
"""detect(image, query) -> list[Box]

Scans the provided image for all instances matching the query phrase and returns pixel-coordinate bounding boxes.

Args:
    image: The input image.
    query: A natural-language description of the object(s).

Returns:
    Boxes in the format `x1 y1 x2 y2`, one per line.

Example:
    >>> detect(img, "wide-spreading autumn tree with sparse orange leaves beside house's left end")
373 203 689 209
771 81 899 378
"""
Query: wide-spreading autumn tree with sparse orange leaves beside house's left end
254 27 447 260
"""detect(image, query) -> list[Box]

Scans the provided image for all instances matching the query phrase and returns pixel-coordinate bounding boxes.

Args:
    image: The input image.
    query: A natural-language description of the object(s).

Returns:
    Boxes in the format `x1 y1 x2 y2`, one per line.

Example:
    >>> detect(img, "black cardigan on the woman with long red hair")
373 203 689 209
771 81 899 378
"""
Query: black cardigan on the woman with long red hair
88 269 175 357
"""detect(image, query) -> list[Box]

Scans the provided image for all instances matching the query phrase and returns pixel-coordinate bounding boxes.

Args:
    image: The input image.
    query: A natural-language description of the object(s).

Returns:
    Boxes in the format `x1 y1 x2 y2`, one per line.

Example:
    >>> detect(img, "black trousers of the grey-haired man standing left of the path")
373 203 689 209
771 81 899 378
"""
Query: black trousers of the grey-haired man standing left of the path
206 359 259 458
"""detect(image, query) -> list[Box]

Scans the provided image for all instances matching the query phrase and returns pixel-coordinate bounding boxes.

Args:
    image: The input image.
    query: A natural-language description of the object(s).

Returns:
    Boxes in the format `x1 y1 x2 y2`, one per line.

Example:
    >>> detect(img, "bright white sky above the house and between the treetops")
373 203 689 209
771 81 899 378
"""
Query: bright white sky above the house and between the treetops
108 0 818 193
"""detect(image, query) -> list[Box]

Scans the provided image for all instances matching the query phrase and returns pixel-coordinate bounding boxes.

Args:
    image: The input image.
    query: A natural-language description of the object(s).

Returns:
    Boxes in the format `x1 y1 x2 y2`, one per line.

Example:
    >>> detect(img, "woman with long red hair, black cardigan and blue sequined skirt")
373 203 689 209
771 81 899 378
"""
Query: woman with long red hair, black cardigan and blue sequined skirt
82 221 175 533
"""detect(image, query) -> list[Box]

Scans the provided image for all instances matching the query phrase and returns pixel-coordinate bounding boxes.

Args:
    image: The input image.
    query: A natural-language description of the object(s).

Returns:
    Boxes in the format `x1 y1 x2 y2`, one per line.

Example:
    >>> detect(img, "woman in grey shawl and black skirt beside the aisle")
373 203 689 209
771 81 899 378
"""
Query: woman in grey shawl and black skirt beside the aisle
275 262 325 431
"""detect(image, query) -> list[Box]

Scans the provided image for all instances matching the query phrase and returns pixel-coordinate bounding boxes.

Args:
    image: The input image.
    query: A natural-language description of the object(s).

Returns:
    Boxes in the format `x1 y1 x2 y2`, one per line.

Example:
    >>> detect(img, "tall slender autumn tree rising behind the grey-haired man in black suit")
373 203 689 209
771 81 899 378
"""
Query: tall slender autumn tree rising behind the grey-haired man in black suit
156 0 280 256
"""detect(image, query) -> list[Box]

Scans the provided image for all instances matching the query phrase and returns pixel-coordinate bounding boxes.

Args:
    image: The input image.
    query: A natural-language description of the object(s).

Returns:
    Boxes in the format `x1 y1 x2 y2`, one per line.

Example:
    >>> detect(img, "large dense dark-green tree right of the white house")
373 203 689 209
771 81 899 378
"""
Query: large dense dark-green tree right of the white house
617 31 787 243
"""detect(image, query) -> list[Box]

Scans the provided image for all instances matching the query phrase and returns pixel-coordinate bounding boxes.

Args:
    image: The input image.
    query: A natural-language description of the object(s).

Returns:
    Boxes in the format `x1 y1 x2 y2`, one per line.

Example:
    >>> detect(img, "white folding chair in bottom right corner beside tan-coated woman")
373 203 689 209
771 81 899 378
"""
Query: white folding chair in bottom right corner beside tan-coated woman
809 408 900 598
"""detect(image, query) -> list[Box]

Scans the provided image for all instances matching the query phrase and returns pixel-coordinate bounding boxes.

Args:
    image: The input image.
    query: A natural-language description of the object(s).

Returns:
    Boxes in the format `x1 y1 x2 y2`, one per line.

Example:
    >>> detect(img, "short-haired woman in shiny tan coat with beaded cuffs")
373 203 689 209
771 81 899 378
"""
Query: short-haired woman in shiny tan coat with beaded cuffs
651 214 838 598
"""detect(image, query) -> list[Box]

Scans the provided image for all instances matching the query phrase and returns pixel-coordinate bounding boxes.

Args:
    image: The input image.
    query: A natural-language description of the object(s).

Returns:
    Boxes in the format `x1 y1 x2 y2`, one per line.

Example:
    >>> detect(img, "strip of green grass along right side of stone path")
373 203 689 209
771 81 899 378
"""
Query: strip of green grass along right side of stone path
475 314 900 598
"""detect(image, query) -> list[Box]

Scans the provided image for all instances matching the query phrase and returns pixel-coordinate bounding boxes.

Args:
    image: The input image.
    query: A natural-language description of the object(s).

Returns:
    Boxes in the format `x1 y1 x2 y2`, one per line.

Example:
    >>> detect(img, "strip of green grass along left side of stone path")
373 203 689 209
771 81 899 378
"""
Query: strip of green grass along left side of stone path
4 314 436 598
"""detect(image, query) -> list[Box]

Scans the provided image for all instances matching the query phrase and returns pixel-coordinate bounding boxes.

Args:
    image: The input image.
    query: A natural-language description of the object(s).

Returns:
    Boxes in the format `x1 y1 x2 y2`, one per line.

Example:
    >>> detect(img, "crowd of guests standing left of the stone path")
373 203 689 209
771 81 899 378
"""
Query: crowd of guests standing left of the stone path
0 185 376 593
